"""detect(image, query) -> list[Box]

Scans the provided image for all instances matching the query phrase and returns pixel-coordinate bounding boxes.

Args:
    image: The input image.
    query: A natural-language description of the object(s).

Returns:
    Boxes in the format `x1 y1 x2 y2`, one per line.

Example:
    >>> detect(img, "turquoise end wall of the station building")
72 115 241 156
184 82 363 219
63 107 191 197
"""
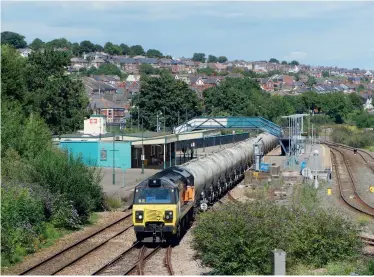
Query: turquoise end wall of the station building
59 141 131 169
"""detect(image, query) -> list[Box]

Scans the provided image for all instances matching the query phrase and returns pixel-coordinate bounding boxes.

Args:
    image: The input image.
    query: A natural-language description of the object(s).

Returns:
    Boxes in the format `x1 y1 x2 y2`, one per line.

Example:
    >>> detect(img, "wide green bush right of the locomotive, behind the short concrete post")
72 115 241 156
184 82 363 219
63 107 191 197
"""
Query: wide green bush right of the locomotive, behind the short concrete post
193 201 361 275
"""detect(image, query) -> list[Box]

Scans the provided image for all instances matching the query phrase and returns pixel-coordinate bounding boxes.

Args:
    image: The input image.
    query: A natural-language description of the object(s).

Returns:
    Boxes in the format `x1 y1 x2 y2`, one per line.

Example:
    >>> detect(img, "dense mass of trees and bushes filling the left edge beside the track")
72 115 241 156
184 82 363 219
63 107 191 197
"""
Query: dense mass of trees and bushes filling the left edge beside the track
1 43 103 266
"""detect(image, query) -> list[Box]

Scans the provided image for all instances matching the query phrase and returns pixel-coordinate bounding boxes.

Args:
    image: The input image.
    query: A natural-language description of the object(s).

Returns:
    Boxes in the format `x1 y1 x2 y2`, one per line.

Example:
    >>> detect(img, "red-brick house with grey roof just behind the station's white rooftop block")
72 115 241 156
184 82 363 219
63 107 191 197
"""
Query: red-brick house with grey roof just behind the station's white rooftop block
89 95 125 123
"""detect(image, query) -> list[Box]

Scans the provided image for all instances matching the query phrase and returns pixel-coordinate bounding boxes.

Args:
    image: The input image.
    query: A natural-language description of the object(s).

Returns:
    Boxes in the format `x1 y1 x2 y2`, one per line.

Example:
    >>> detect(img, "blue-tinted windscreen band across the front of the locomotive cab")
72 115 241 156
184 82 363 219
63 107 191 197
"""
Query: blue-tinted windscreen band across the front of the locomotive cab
134 187 176 204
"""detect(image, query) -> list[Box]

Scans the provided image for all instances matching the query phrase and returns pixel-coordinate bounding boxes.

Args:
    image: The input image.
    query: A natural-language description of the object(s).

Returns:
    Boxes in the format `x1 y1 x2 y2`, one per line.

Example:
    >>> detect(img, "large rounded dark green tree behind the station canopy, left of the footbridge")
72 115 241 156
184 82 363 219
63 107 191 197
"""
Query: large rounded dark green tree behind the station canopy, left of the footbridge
131 73 200 130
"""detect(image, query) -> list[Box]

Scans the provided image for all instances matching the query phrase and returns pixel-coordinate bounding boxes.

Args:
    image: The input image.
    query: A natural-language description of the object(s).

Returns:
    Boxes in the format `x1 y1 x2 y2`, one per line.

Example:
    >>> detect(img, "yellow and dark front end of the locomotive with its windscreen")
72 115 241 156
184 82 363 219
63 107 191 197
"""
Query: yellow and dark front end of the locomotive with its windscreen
132 179 178 242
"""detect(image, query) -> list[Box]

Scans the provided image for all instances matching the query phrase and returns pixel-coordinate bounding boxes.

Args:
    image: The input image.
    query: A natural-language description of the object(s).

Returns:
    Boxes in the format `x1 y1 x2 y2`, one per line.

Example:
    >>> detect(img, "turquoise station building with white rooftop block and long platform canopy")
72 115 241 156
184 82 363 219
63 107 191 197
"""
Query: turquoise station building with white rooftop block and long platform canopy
53 115 249 170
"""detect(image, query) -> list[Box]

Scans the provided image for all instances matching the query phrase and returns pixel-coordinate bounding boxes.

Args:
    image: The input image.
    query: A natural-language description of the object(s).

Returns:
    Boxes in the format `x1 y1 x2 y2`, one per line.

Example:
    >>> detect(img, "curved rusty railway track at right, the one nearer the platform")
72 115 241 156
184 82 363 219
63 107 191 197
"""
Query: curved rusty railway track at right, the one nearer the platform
329 144 374 217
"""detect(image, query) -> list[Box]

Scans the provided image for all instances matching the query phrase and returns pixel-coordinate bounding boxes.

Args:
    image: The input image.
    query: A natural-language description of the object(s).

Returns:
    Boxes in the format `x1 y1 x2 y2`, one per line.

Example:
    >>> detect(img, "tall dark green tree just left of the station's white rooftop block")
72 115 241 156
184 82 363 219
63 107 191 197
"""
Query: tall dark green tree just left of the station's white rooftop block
24 49 88 134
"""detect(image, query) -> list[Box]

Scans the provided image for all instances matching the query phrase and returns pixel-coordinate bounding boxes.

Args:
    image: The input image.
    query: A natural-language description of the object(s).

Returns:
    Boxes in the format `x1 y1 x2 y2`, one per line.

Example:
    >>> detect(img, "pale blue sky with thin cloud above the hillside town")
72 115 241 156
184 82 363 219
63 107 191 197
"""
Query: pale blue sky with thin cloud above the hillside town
1 1 374 69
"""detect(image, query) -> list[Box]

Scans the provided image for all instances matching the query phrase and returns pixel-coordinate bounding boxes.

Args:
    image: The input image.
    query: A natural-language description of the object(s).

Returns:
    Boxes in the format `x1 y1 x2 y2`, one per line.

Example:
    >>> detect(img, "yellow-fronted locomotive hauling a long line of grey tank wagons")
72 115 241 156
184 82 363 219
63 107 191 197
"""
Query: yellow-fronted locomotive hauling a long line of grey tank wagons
132 133 278 242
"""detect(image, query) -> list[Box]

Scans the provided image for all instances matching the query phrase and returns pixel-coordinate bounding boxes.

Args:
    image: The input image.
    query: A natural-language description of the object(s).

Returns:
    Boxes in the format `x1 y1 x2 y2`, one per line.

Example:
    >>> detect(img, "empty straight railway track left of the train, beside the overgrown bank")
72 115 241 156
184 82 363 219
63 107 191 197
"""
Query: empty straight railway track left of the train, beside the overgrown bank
18 210 133 275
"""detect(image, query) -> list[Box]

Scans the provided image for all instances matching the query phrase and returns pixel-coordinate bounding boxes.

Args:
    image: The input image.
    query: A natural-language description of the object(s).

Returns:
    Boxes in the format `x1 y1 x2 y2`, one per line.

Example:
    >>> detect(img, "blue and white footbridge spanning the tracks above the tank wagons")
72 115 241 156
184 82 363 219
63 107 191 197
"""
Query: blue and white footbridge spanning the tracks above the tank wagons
174 116 283 138
